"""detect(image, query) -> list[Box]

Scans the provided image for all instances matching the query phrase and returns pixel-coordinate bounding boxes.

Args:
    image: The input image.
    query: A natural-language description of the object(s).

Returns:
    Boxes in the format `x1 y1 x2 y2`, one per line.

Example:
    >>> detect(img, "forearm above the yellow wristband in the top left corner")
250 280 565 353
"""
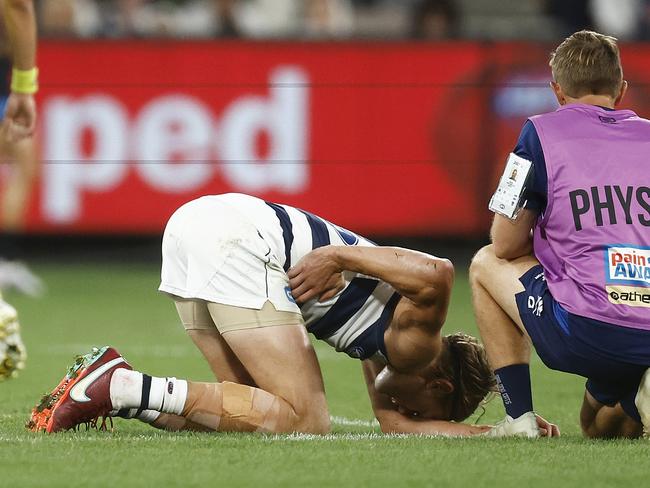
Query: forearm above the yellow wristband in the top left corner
3 0 36 70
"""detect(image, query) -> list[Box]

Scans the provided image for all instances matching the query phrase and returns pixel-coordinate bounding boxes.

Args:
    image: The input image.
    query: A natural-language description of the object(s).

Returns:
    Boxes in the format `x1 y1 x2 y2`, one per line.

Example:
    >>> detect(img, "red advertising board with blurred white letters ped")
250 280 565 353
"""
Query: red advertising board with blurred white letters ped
22 41 650 236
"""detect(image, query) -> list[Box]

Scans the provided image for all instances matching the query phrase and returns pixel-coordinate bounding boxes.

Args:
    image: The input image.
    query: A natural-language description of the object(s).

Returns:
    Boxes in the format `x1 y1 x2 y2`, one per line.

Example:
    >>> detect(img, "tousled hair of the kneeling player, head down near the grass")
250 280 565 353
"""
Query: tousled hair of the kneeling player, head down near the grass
440 332 496 422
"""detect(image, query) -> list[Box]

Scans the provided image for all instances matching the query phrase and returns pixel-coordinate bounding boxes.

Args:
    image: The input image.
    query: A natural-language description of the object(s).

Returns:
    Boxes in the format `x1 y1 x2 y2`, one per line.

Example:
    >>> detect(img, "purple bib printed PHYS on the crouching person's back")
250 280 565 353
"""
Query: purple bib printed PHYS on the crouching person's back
530 104 650 330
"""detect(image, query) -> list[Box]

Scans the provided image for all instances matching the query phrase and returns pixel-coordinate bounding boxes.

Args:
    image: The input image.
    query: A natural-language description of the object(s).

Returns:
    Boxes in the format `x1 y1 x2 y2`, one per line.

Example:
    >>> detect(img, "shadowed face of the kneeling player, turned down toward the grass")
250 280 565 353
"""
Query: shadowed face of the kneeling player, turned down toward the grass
375 366 450 420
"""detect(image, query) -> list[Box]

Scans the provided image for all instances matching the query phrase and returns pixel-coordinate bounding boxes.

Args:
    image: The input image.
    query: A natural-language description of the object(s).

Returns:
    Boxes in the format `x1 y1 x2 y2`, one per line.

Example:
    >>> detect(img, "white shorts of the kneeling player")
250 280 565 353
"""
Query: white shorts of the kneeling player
159 198 300 313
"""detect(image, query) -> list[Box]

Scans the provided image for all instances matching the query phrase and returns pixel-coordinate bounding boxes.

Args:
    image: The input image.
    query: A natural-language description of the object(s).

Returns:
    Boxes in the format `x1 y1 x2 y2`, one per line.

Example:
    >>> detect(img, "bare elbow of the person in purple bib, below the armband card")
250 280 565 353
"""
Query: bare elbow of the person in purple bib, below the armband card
490 209 537 259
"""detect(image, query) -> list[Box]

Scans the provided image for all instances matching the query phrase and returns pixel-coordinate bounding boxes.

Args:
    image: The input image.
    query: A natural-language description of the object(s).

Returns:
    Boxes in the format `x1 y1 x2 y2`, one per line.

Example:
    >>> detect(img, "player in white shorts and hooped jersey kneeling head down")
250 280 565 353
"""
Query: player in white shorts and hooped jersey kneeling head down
31 194 547 435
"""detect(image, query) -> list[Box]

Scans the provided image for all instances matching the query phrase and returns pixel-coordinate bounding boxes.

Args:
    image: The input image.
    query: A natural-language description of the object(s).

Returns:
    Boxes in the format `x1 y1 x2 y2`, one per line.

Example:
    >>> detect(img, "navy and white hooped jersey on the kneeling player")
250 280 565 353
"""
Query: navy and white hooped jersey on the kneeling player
221 193 400 359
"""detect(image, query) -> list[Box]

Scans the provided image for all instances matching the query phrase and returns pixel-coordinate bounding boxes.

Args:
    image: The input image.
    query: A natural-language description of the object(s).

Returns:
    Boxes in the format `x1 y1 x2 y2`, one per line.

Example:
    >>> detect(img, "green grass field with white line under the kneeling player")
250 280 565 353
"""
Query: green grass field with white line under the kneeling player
0 264 650 488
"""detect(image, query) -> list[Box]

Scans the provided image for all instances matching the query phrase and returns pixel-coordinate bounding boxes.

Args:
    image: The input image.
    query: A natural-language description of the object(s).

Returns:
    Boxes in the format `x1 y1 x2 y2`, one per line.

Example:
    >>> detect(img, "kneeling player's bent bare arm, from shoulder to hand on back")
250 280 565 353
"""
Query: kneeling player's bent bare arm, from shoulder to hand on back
289 246 454 373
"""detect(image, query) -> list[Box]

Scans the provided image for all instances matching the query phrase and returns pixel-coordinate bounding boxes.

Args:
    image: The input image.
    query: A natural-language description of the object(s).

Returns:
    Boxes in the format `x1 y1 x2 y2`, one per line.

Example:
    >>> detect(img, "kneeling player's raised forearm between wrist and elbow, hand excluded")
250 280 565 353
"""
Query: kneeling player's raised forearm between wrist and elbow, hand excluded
332 246 454 302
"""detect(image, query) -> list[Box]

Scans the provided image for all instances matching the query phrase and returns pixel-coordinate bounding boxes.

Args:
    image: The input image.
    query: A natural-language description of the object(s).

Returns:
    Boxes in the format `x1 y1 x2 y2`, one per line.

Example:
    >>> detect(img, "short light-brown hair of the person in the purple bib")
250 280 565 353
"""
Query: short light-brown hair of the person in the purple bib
549 30 623 98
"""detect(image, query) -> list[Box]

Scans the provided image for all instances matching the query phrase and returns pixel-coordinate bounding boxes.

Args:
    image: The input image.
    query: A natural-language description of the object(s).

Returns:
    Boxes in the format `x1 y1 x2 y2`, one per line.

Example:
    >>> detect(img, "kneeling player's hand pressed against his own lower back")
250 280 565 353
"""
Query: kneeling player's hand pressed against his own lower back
288 246 345 304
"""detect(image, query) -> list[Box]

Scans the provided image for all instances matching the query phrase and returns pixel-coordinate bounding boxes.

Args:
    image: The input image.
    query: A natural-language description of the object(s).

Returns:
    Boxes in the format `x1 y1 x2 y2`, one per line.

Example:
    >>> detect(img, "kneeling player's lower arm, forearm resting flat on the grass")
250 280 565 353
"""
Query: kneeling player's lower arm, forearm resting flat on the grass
362 359 489 437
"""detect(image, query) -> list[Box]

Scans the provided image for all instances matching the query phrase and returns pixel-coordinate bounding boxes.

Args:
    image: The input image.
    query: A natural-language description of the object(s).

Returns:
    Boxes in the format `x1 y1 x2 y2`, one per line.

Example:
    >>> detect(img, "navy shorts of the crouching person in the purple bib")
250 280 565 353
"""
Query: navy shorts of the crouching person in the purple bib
515 265 650 417
